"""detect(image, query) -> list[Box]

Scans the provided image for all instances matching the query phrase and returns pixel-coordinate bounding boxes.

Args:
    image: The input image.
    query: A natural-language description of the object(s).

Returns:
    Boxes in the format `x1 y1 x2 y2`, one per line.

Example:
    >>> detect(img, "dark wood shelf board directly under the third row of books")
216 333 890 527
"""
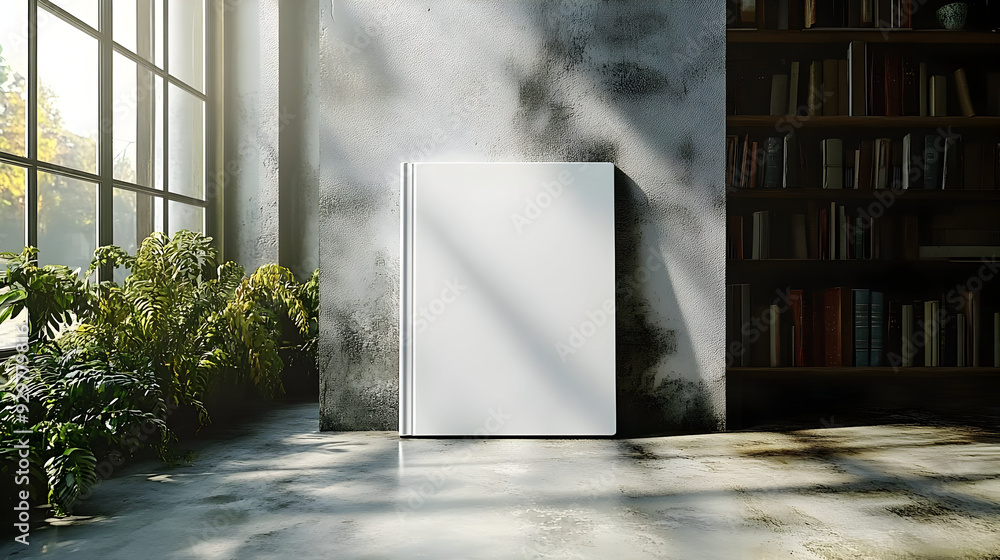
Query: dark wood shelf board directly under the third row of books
726 189 1000 203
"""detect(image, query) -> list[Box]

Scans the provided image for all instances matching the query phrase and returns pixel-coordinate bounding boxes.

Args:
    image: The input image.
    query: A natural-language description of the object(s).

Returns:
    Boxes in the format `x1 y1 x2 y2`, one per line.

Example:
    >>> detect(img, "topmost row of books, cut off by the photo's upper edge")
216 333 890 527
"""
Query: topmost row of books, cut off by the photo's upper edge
727 0 918 29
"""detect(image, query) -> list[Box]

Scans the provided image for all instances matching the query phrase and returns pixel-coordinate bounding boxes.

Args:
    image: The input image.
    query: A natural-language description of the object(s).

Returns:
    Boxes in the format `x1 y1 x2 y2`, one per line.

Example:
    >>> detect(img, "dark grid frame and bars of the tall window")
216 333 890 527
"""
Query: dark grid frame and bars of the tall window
0 0 224 280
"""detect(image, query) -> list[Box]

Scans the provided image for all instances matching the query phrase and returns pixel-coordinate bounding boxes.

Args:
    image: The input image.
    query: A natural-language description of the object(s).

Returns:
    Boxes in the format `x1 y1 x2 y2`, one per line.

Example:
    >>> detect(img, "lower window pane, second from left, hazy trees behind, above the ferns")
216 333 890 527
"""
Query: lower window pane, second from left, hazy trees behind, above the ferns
38 171 97 274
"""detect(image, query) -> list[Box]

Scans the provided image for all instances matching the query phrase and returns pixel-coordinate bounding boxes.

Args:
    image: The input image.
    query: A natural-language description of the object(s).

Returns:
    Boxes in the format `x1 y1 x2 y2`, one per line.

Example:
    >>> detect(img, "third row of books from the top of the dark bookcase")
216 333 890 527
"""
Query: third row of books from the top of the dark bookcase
726 133 1000 190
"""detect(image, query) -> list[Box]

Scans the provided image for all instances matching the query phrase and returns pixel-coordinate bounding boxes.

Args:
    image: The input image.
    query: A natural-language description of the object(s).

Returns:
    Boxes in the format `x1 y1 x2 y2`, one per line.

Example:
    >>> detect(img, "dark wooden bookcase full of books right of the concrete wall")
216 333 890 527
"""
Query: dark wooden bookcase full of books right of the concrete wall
726 0 1000 424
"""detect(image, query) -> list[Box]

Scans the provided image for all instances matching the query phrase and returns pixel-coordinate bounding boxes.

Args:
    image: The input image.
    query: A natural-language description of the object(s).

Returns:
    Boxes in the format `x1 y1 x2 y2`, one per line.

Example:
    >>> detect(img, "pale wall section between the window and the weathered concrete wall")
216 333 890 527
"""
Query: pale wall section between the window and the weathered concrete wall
223 0 319 278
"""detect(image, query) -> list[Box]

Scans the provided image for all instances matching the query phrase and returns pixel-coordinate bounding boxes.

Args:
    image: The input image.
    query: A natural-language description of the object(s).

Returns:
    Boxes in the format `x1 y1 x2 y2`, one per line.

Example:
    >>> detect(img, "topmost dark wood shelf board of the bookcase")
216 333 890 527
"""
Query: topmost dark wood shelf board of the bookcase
726 28 1000 45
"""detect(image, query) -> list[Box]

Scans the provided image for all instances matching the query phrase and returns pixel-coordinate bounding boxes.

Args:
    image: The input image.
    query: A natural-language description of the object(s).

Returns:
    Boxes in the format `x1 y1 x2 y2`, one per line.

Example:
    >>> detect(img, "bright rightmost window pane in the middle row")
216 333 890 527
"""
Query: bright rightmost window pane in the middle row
167 84 205 198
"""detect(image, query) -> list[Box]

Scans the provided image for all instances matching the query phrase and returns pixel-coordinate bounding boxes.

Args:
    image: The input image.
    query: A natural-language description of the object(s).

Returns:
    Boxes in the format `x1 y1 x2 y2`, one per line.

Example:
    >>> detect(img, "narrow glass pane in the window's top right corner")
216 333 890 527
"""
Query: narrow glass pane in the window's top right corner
167 0 205 91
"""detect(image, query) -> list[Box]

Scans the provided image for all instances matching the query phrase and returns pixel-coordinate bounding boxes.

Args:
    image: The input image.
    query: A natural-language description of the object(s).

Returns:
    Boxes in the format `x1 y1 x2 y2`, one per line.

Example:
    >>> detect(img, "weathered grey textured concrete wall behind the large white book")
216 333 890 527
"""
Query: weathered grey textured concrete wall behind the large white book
318 0 725 434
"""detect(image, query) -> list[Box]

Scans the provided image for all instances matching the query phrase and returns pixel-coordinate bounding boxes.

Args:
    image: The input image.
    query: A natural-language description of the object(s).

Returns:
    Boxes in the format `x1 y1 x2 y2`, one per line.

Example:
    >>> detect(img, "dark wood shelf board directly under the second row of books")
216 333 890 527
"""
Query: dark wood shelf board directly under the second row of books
726 115 1000 129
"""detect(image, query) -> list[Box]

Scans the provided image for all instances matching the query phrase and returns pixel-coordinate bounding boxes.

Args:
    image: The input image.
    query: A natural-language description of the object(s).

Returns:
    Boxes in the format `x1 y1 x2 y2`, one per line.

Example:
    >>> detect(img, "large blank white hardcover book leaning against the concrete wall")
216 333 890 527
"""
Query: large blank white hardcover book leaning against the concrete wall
399 163 616 436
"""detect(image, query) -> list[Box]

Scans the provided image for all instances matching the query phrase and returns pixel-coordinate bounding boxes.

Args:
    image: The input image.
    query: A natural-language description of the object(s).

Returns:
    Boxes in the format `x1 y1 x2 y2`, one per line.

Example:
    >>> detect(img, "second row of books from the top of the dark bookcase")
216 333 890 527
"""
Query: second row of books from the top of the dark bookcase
727 46 1000 117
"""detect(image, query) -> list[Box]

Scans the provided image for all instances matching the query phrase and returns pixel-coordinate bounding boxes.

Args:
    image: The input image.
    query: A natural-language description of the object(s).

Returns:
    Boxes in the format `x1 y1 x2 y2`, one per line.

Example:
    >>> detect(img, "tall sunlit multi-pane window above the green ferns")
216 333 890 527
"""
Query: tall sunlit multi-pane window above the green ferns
0 0 218 346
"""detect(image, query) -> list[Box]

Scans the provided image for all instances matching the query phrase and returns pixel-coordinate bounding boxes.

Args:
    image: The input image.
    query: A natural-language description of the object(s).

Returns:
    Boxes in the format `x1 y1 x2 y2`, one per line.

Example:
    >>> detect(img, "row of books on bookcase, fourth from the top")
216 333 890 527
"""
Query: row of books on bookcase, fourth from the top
726 209 884 260
